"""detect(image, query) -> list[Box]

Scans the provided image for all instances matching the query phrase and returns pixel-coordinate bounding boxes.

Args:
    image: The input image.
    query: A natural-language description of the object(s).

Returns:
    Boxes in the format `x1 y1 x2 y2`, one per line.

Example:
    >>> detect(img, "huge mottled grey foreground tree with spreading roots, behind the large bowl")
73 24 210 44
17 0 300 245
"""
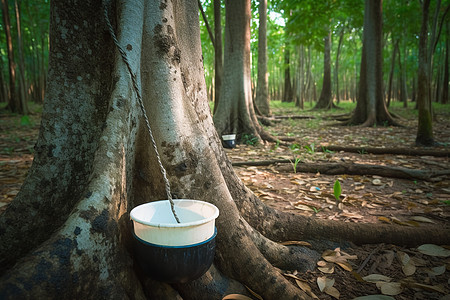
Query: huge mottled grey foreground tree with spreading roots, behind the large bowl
0 0 450 299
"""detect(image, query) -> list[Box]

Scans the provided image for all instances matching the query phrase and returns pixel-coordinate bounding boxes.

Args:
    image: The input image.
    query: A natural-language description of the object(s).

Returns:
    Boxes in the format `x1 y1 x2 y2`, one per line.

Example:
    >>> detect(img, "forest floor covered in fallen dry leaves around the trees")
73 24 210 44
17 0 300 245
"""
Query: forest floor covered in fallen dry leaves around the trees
0 101 450 300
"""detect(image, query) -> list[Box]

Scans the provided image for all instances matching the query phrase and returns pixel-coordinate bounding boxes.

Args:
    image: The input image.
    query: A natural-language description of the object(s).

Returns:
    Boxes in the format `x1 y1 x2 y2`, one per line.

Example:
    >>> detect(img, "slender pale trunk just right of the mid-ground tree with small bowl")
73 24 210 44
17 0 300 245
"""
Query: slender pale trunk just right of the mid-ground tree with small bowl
256 0 270 116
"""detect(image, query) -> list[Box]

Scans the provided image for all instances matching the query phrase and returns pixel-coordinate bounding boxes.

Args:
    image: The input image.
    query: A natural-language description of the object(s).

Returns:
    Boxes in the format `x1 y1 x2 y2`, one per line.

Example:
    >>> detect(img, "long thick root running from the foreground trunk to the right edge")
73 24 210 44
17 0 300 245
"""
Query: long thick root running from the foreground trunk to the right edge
221 164 450 246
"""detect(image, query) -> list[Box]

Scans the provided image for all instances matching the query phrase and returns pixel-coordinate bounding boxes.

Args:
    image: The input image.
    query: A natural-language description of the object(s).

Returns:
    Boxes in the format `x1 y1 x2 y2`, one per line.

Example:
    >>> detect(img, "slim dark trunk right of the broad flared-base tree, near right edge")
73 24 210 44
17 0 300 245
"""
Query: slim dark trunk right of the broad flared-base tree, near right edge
416 0 434 146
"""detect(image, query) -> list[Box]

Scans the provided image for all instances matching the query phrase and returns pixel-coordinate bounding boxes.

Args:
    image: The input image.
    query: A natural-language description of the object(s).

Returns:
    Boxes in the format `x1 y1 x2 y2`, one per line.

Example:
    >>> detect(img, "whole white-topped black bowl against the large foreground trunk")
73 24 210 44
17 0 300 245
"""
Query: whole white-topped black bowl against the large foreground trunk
130 199 219 283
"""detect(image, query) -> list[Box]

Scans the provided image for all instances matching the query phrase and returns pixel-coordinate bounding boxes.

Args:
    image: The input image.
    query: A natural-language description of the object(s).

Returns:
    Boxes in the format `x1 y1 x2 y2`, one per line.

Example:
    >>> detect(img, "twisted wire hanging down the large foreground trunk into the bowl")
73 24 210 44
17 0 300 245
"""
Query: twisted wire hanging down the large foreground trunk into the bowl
104 1 180 223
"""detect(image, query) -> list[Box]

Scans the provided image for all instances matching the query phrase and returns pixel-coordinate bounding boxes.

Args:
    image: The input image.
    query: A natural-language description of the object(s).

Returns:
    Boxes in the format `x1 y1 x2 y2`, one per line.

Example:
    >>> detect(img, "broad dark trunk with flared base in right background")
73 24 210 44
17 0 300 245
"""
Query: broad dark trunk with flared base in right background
349 0 397 126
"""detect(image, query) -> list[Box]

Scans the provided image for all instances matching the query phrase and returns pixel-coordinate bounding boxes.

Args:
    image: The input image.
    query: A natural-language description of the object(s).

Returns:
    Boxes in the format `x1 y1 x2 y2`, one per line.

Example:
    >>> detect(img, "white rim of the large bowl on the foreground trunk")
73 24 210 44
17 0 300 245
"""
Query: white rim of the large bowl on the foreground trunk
130 199 219 228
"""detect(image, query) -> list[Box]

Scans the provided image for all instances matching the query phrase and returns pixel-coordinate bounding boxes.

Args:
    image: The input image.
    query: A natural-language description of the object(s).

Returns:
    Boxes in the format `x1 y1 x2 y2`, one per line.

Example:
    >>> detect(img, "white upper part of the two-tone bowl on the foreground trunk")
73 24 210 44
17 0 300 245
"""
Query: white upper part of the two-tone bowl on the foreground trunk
130 199 219 246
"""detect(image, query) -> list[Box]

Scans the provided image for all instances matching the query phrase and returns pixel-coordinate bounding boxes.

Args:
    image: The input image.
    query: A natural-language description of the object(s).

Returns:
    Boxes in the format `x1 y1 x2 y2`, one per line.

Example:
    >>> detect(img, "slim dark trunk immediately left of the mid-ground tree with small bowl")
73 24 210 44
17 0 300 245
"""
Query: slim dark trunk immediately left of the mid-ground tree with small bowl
214 0 223 112
